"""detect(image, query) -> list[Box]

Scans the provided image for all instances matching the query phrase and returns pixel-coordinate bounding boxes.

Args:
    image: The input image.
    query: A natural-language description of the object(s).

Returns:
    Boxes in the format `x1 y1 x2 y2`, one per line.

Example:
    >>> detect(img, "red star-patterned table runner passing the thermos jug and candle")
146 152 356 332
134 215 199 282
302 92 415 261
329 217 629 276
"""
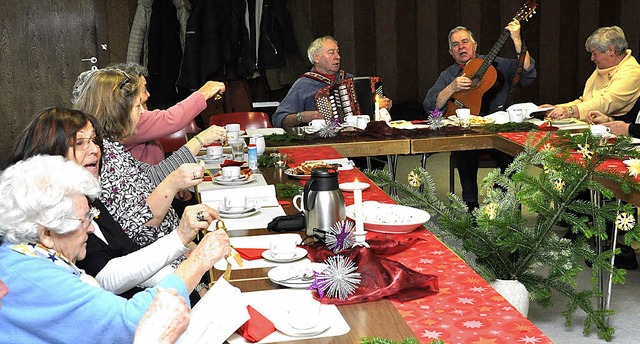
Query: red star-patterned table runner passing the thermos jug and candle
280 147 552 344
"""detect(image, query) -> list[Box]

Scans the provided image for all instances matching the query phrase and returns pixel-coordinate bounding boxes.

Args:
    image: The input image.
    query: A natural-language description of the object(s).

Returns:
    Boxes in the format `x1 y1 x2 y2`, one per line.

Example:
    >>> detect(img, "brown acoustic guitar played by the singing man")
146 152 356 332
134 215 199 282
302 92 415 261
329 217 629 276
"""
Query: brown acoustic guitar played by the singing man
445 0 537 117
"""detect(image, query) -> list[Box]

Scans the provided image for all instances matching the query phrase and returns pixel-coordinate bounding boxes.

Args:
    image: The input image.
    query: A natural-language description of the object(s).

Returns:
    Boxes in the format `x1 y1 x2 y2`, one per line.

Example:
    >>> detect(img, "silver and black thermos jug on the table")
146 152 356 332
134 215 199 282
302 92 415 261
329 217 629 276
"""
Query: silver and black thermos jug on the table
293 167 346 238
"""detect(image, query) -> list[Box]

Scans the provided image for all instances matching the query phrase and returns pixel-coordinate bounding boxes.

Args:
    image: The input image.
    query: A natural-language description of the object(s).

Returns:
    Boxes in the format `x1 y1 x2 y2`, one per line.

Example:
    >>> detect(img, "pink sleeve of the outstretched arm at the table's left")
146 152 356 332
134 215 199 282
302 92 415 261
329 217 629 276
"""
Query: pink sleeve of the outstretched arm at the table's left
125 92 207 144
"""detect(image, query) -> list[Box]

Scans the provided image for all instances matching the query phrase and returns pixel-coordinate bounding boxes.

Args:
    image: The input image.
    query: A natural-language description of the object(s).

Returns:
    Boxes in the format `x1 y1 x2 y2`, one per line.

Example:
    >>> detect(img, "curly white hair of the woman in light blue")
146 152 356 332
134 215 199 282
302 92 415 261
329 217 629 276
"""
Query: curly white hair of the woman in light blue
0 155 100 243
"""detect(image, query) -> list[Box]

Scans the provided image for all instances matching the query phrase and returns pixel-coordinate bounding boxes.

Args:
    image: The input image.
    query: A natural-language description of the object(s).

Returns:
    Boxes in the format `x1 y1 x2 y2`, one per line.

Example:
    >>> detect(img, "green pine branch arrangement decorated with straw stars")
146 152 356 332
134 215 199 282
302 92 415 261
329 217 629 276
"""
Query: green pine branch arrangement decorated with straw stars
367 131 640 341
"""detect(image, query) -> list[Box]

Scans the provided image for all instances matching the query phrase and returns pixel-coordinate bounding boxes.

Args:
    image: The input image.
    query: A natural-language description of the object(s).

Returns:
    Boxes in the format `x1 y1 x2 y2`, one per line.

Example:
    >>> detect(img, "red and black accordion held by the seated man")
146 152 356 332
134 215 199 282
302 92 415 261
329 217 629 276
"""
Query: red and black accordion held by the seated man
315 76 384 123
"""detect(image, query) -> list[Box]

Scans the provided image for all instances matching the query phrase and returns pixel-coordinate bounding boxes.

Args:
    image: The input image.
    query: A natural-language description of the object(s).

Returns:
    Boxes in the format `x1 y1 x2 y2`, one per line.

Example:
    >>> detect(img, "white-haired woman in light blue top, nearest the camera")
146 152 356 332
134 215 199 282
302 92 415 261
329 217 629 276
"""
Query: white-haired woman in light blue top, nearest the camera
0 155 231 343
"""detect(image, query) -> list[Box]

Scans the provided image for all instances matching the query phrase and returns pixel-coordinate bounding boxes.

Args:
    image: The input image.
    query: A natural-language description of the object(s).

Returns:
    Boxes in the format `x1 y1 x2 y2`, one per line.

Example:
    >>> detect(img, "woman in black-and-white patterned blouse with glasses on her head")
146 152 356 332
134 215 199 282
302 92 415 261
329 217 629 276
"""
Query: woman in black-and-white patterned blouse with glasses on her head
74 69 226 246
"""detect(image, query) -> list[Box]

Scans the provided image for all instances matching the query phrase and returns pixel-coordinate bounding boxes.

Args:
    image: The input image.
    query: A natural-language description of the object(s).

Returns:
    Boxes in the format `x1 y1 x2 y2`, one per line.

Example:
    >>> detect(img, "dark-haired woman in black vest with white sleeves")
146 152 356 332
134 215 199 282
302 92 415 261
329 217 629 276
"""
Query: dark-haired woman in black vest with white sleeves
12 108 220 298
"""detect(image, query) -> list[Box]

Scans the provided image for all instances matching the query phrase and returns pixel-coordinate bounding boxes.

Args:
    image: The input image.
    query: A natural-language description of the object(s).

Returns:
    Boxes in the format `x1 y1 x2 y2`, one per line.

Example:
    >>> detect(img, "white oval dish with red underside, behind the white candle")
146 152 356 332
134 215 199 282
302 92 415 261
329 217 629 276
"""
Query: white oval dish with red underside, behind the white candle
346 201 431 234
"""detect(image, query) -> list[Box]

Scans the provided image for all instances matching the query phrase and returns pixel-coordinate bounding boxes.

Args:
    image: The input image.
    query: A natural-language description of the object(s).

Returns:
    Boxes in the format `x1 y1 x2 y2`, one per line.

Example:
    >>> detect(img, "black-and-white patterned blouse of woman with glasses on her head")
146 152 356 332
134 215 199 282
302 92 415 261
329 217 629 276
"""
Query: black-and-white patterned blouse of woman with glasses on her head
100 139 195 246
